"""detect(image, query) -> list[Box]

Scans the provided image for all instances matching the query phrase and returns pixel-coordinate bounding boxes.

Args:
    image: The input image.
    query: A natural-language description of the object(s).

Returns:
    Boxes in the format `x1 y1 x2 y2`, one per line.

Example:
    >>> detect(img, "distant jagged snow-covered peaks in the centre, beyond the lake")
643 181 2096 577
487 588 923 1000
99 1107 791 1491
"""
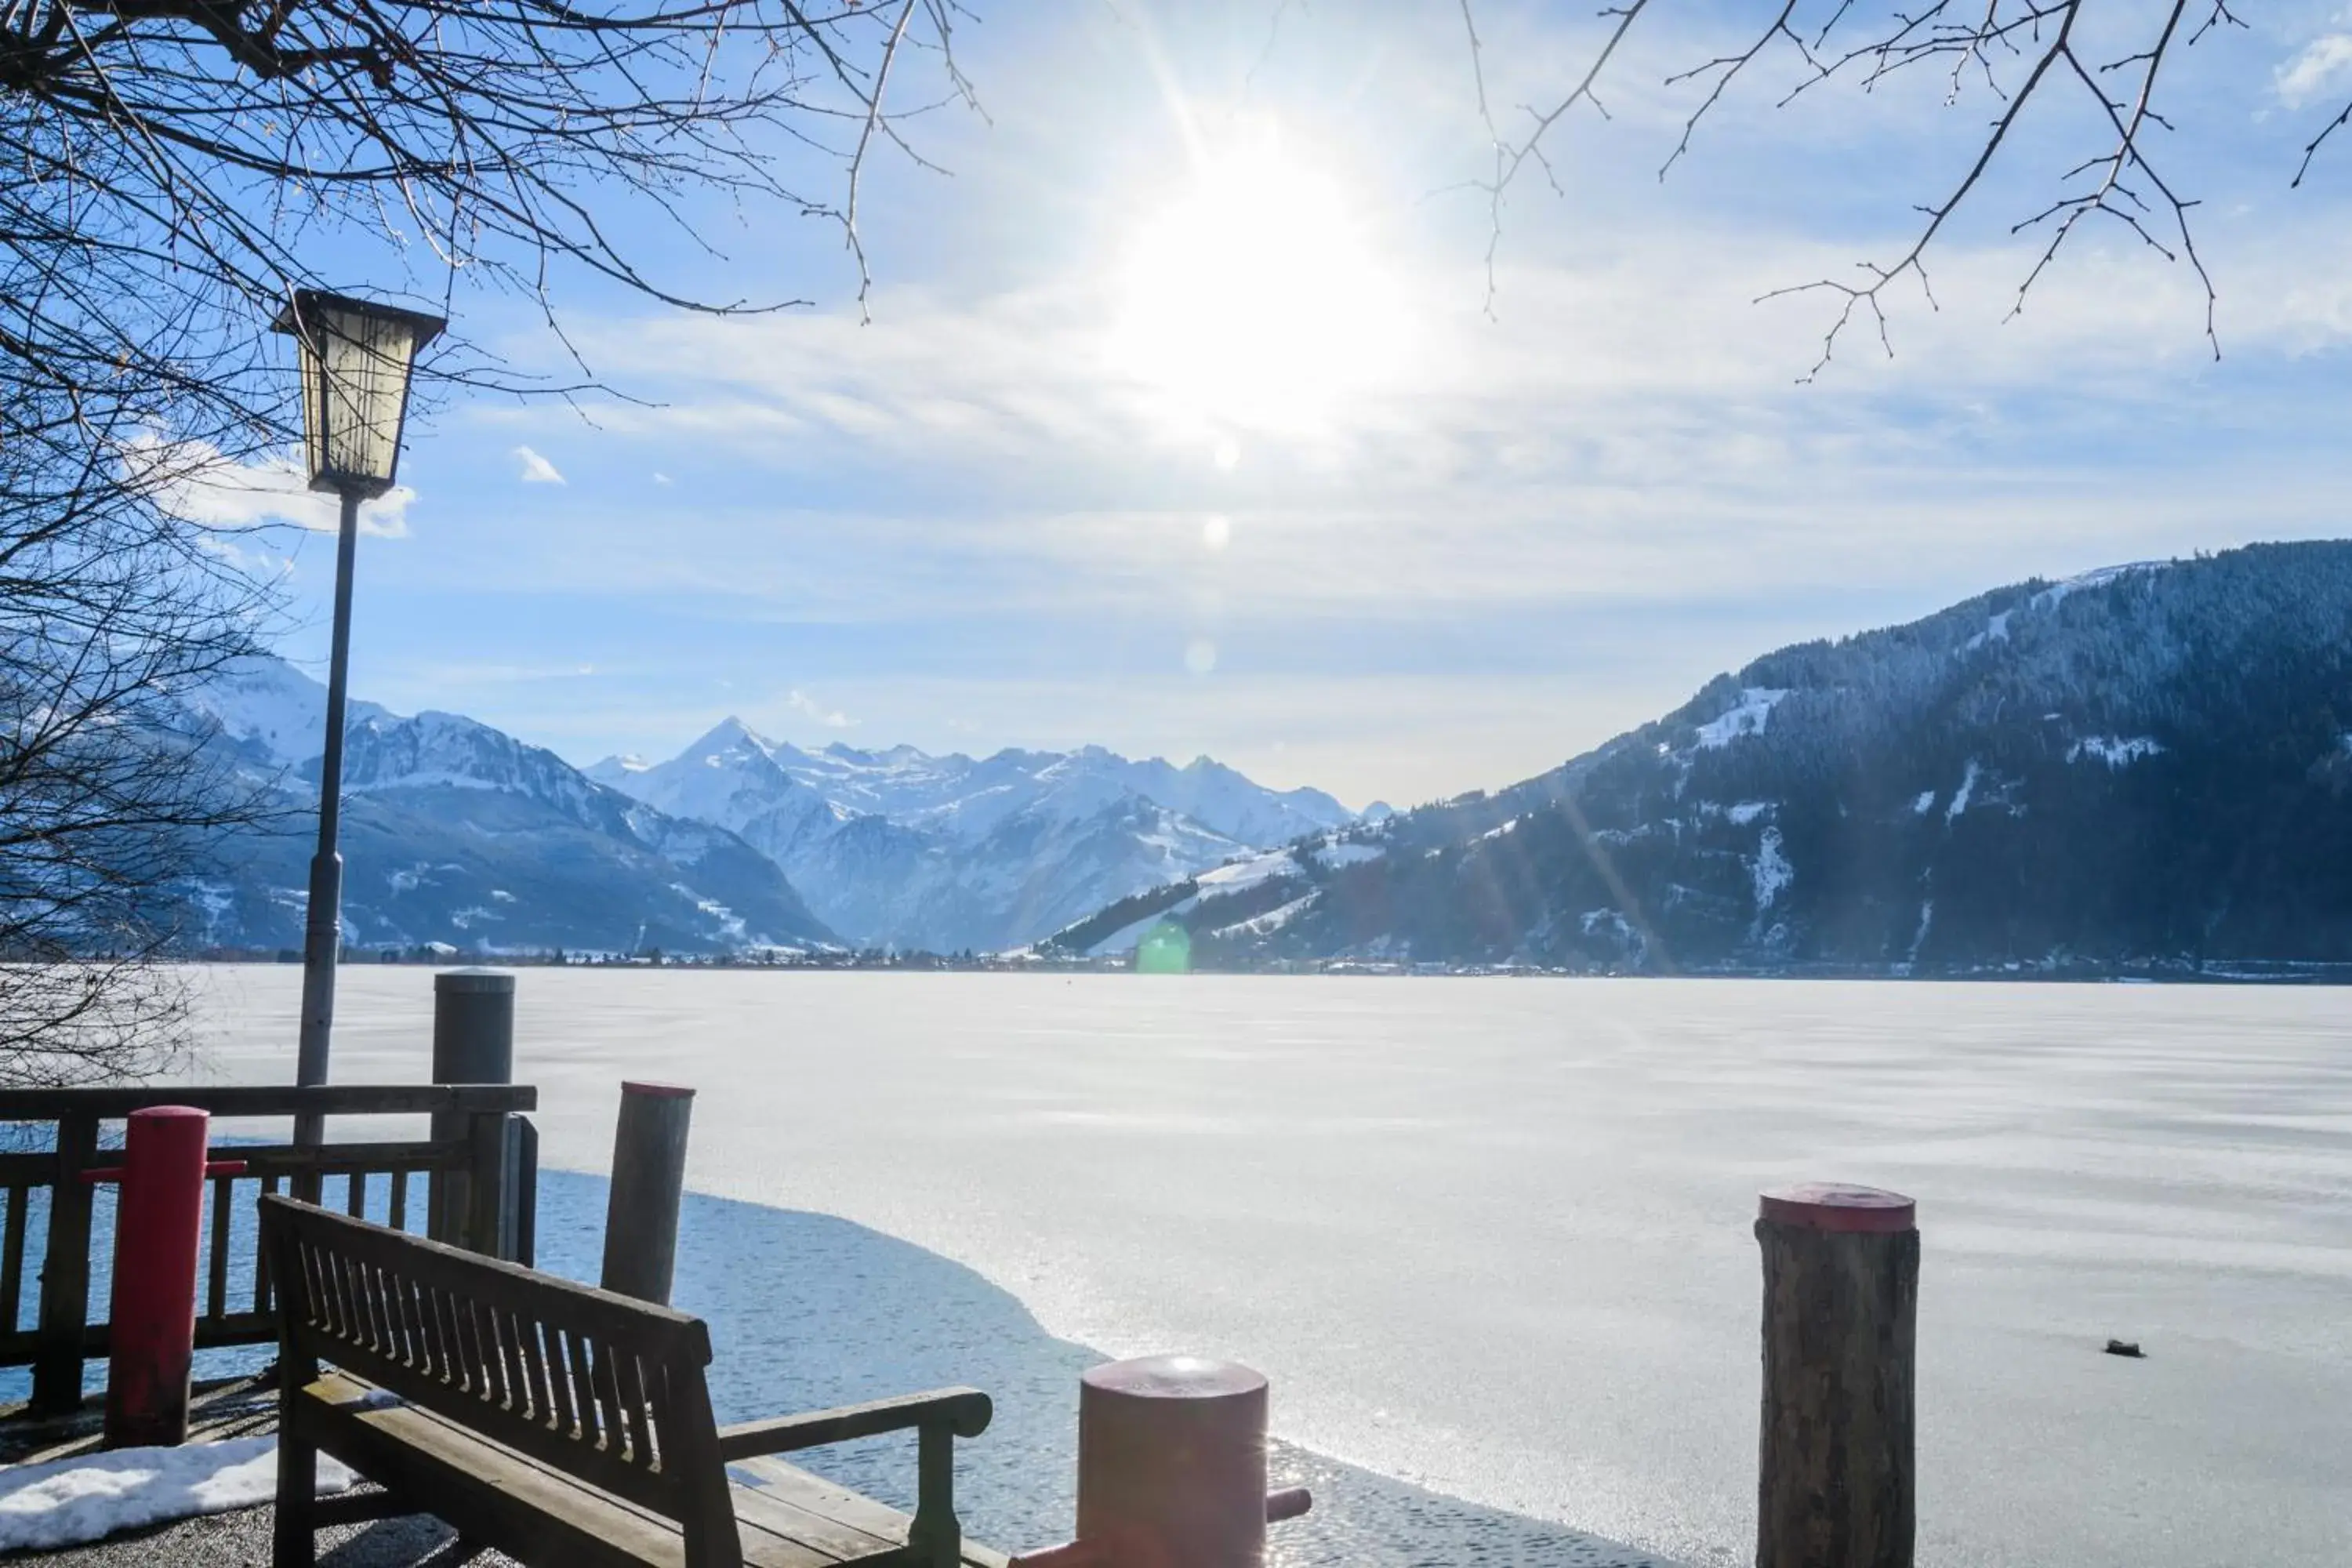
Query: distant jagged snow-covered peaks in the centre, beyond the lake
588 720 1355 952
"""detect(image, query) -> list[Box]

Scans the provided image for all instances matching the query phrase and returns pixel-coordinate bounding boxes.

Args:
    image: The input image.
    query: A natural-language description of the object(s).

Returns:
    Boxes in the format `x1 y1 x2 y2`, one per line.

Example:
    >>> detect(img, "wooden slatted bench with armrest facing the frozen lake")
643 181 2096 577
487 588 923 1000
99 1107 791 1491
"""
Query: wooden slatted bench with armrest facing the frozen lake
261 1196 1004 1568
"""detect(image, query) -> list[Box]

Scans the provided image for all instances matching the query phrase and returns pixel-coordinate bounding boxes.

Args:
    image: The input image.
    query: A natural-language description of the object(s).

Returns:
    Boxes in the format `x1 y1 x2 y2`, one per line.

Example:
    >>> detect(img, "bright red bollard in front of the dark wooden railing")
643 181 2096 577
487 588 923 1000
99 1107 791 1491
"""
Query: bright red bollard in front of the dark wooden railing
89 1105 214 1448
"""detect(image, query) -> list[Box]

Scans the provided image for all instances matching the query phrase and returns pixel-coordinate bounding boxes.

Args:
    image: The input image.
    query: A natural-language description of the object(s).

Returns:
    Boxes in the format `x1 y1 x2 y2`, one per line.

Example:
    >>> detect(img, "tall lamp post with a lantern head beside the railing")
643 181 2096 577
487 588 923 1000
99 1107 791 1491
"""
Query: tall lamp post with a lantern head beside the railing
278 289 447 1145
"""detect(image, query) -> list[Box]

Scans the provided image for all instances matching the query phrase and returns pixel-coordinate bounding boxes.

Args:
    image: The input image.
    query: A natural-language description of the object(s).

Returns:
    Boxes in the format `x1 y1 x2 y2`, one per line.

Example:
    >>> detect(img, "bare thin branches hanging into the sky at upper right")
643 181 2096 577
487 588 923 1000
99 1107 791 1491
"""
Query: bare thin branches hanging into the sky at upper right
1461 0 2352 374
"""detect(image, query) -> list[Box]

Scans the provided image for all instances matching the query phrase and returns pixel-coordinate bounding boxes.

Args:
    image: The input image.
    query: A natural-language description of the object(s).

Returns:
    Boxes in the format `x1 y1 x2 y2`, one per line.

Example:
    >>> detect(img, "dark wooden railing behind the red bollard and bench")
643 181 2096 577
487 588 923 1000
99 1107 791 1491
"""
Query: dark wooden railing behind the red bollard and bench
0 1083 539 1415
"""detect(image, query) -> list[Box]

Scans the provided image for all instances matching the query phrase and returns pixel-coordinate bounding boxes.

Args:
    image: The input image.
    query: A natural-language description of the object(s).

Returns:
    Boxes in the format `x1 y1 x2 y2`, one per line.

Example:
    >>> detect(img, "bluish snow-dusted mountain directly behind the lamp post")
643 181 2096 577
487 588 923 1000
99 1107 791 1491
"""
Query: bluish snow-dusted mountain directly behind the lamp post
174 659 833 952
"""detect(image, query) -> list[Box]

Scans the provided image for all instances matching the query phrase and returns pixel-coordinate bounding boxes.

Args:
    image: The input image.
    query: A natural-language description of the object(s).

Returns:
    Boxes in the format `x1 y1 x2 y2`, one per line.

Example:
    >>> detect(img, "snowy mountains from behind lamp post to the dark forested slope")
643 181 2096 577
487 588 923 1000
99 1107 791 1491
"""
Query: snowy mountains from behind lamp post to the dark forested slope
181 659 1355 954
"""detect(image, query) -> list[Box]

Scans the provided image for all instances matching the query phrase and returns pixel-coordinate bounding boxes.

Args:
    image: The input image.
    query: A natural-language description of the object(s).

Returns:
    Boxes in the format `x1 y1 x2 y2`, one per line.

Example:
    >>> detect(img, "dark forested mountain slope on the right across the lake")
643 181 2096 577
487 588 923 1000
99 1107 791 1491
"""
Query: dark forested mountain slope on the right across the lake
1042 543 2352 973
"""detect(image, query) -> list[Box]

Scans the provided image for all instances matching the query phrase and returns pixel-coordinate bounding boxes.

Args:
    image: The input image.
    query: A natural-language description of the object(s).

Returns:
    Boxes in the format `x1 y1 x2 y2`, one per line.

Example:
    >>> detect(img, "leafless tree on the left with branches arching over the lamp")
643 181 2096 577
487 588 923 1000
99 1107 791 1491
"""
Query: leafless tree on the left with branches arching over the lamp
0 0 969 1081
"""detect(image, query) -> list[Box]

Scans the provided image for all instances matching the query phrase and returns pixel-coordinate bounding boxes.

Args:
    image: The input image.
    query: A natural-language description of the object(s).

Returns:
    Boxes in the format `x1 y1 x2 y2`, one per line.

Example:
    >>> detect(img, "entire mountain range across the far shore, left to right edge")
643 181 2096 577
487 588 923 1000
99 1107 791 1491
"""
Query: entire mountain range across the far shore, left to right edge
186 543 2352 973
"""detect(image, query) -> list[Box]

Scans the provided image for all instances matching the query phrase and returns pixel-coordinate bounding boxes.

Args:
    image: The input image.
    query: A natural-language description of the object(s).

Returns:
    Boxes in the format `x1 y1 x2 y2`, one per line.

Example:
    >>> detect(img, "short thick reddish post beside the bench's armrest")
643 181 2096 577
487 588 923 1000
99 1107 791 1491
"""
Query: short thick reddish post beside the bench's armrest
1014 1356 1312 1568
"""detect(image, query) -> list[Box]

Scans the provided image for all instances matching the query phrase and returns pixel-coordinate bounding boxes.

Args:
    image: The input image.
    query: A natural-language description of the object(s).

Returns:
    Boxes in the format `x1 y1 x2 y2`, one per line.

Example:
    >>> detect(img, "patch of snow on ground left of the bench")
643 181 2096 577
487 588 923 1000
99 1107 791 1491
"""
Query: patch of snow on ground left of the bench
0 1436 355 1552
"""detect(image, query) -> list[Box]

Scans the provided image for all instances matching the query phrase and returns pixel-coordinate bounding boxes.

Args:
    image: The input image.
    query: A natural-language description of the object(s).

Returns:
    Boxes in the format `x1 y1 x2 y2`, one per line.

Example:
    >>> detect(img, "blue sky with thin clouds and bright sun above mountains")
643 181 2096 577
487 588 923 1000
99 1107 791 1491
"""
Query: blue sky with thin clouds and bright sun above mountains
198 0 2352 804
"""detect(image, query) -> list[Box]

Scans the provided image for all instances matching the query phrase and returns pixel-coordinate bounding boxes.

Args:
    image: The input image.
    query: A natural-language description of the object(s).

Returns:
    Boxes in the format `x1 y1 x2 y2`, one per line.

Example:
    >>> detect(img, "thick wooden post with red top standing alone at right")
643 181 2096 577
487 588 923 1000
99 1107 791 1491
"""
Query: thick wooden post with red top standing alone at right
1757 1182 1919 1568
